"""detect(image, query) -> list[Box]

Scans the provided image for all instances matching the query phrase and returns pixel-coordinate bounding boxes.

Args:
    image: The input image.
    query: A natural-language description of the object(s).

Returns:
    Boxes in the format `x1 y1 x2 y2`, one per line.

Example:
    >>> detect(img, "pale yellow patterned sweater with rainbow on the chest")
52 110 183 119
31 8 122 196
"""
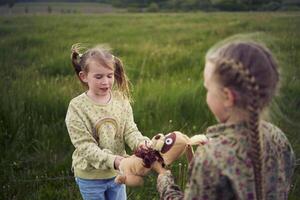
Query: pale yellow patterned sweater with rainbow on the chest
66 92 149 179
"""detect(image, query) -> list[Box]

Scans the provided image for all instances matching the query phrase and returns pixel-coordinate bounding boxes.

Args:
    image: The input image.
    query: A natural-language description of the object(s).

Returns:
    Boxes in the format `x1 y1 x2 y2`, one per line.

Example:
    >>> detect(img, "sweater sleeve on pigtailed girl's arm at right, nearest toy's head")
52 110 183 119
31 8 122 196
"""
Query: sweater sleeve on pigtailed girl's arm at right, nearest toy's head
124 102 150 150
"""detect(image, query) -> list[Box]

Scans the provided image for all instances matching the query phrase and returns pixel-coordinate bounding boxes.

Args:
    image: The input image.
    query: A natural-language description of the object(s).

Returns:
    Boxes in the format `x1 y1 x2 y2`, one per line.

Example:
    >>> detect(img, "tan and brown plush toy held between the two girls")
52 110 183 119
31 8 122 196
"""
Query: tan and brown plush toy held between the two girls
115 131 208 186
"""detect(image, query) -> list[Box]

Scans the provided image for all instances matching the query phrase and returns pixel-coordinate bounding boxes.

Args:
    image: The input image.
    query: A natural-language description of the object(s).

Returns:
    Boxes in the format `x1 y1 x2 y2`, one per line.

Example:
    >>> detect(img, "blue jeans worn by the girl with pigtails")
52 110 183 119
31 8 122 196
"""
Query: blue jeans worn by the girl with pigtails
75 177 127 200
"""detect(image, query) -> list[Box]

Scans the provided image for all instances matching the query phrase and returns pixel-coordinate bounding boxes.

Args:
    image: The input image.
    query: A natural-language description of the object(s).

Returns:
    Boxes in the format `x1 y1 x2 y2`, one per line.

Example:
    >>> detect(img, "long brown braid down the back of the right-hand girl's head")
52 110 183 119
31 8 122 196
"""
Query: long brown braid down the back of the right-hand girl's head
219 59 263 200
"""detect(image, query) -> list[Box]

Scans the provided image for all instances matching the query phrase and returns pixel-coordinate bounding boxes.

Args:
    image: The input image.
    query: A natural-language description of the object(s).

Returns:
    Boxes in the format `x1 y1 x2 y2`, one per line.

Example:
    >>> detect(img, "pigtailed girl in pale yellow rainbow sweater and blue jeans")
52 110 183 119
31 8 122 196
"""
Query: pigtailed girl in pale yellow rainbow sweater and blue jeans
66 45 149 200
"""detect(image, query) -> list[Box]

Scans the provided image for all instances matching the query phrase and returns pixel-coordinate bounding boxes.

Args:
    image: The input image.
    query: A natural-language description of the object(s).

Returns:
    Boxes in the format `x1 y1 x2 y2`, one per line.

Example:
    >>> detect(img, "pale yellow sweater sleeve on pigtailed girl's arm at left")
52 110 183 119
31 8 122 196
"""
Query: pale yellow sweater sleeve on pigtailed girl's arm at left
66 102 116 169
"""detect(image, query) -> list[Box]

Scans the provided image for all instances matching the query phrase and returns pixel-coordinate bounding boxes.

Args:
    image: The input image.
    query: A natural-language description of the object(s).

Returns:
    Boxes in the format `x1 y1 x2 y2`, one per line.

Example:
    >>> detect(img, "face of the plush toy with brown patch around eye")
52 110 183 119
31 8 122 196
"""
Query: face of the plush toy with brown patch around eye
152 132 188 165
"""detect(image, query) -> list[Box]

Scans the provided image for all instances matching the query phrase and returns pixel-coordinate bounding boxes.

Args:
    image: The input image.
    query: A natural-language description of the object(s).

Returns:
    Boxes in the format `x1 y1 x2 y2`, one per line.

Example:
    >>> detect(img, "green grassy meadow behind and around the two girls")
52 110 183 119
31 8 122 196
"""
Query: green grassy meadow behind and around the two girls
0 12 300 200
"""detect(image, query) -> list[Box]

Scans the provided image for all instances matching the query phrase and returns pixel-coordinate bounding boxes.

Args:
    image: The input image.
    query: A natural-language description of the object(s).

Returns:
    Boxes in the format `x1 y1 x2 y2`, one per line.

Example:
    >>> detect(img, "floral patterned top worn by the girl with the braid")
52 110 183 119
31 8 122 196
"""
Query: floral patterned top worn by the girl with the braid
157 122 295 200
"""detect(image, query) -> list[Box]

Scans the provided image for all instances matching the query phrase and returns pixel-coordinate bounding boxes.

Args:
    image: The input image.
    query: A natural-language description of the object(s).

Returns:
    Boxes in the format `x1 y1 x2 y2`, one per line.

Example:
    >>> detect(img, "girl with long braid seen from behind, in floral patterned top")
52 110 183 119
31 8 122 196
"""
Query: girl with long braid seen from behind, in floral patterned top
152 41 295 200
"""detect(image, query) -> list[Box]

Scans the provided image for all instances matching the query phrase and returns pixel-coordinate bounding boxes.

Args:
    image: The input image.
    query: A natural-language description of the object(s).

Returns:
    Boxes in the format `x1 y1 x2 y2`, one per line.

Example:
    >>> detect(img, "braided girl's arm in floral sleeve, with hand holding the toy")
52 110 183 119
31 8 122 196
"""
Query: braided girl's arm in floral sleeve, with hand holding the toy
152 147 234 200
